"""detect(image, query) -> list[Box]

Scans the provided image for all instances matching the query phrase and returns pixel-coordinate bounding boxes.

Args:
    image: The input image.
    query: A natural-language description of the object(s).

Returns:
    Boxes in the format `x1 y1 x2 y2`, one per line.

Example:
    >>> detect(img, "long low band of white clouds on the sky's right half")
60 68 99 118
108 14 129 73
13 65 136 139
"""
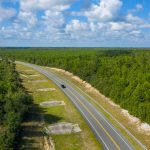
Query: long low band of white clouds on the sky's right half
65 16 150 43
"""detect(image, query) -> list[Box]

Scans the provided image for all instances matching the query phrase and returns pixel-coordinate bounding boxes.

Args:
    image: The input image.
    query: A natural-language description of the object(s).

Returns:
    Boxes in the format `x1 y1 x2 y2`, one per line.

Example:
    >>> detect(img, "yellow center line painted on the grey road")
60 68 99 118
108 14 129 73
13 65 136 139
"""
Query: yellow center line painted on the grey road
68 89 120 150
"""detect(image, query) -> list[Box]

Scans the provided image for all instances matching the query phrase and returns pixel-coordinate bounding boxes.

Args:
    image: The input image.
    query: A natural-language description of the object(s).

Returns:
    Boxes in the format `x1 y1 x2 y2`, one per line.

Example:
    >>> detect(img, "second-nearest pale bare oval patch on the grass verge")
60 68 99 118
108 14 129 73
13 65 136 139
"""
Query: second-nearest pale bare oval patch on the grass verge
40 101 65 107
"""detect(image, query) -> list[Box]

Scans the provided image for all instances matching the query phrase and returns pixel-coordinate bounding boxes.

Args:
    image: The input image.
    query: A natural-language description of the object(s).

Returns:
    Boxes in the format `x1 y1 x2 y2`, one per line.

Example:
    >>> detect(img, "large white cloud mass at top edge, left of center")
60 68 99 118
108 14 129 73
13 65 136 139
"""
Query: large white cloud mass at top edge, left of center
14 0 75 37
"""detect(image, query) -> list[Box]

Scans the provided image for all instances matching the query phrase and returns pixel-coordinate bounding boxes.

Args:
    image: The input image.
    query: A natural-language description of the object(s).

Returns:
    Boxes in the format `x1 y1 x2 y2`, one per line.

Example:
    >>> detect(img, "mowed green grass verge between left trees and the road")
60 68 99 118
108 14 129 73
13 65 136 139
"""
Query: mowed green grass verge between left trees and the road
17 64 102 150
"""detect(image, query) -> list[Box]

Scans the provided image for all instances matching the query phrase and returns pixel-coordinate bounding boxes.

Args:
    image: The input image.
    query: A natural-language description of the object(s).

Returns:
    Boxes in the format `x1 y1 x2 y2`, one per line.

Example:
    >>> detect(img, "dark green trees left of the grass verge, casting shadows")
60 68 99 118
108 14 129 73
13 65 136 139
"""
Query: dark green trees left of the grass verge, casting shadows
0 59 32 150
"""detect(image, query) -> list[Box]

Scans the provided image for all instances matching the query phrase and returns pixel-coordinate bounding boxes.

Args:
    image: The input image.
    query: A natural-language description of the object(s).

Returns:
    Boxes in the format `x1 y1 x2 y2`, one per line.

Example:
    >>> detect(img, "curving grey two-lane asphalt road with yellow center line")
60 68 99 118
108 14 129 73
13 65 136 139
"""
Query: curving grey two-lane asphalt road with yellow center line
17 62 145 150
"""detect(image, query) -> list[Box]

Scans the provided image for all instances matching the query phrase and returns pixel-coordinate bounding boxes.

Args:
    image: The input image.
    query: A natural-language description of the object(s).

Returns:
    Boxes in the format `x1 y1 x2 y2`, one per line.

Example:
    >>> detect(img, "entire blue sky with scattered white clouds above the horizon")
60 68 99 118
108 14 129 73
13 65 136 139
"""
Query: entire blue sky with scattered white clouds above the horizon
0 0 150 47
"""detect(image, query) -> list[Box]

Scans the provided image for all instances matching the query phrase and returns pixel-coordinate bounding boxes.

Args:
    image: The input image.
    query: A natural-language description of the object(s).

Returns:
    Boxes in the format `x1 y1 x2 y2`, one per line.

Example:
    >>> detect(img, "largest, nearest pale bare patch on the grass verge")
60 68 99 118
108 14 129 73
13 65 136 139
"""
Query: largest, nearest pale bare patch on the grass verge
46 122 81 134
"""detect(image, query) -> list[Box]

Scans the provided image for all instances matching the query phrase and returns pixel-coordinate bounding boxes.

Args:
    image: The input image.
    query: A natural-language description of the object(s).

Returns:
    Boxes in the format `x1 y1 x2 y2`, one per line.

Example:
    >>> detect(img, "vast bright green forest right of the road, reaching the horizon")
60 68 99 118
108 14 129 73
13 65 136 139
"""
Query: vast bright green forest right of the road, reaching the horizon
0 48 150 124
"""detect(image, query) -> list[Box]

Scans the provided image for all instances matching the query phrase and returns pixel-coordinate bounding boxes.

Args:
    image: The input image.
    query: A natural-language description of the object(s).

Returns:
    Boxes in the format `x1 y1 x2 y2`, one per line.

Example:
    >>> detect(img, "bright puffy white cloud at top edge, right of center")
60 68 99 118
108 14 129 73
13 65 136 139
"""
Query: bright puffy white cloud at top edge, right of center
84 0 122 21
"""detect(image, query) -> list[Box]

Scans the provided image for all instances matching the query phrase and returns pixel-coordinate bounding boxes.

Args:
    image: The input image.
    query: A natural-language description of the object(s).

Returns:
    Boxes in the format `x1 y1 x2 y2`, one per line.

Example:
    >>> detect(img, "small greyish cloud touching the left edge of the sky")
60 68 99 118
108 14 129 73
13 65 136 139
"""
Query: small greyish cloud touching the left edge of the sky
0 6 17 22
